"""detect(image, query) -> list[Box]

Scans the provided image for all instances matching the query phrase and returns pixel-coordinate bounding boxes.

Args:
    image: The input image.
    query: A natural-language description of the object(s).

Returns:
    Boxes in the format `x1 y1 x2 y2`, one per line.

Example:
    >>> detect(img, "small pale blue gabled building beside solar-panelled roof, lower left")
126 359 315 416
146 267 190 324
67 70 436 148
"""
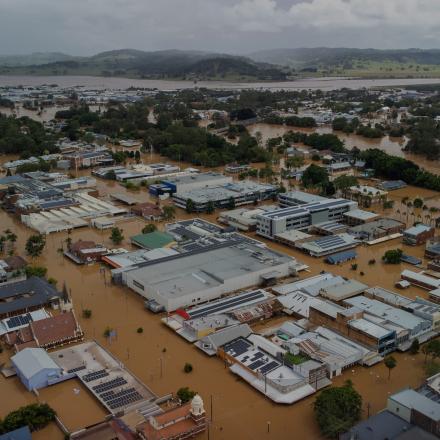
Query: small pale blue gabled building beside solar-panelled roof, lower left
11 348 62 391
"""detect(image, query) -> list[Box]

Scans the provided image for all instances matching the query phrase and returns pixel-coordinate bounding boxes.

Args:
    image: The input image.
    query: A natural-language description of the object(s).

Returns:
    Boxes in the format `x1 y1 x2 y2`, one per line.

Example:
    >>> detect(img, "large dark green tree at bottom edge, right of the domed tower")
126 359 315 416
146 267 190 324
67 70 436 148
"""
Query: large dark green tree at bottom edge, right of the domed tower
314 381 362 438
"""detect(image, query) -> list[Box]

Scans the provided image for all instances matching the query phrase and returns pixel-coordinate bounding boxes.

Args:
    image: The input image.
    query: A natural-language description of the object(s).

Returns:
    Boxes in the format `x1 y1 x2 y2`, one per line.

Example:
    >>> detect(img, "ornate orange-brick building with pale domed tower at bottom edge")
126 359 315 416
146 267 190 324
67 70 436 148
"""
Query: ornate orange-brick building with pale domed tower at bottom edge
137 394 207 440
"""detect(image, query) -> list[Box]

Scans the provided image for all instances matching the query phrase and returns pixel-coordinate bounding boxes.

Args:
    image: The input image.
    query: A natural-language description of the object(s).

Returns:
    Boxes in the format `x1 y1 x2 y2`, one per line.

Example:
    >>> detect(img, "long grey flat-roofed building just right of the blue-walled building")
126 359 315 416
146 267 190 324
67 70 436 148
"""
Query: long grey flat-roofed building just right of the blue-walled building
173 181 278 212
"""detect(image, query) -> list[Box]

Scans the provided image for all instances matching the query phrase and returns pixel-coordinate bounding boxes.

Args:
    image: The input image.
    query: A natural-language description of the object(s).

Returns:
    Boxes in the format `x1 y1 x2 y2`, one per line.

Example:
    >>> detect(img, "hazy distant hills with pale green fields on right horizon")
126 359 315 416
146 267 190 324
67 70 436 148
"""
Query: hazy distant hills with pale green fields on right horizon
249 47 440 76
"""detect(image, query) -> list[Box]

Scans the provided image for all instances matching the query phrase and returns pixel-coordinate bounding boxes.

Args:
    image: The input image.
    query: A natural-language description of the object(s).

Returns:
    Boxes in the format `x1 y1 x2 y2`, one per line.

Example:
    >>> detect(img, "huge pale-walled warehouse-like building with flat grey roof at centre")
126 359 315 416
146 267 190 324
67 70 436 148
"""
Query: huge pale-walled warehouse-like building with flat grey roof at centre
121 236 296 311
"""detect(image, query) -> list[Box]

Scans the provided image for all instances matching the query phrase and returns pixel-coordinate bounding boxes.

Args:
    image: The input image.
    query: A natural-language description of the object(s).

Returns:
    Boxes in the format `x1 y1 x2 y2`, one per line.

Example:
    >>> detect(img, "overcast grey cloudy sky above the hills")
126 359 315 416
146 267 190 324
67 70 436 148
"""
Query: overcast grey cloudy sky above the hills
0 0 440 55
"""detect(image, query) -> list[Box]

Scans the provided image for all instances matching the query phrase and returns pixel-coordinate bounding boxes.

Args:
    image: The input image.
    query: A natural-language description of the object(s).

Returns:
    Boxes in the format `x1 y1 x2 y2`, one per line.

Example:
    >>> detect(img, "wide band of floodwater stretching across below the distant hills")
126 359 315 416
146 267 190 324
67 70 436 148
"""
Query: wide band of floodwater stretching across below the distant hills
0 75 440 90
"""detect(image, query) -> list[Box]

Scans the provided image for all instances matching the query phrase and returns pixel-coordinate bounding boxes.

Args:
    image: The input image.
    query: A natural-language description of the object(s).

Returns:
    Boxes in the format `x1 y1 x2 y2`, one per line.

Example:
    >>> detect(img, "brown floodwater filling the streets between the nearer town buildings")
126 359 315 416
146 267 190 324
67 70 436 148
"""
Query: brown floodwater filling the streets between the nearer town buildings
0 155 439 440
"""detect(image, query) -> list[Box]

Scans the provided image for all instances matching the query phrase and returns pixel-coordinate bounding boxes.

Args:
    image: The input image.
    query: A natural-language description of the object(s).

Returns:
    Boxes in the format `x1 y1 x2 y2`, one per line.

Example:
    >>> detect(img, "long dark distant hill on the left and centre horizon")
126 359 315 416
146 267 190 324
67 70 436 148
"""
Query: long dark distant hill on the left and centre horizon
0 49 286 80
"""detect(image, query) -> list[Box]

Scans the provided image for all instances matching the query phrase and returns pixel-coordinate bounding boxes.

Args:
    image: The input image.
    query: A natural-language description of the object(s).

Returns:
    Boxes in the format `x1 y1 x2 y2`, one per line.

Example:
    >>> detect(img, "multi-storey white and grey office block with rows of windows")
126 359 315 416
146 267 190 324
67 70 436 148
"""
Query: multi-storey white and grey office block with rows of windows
257 191 357 239
